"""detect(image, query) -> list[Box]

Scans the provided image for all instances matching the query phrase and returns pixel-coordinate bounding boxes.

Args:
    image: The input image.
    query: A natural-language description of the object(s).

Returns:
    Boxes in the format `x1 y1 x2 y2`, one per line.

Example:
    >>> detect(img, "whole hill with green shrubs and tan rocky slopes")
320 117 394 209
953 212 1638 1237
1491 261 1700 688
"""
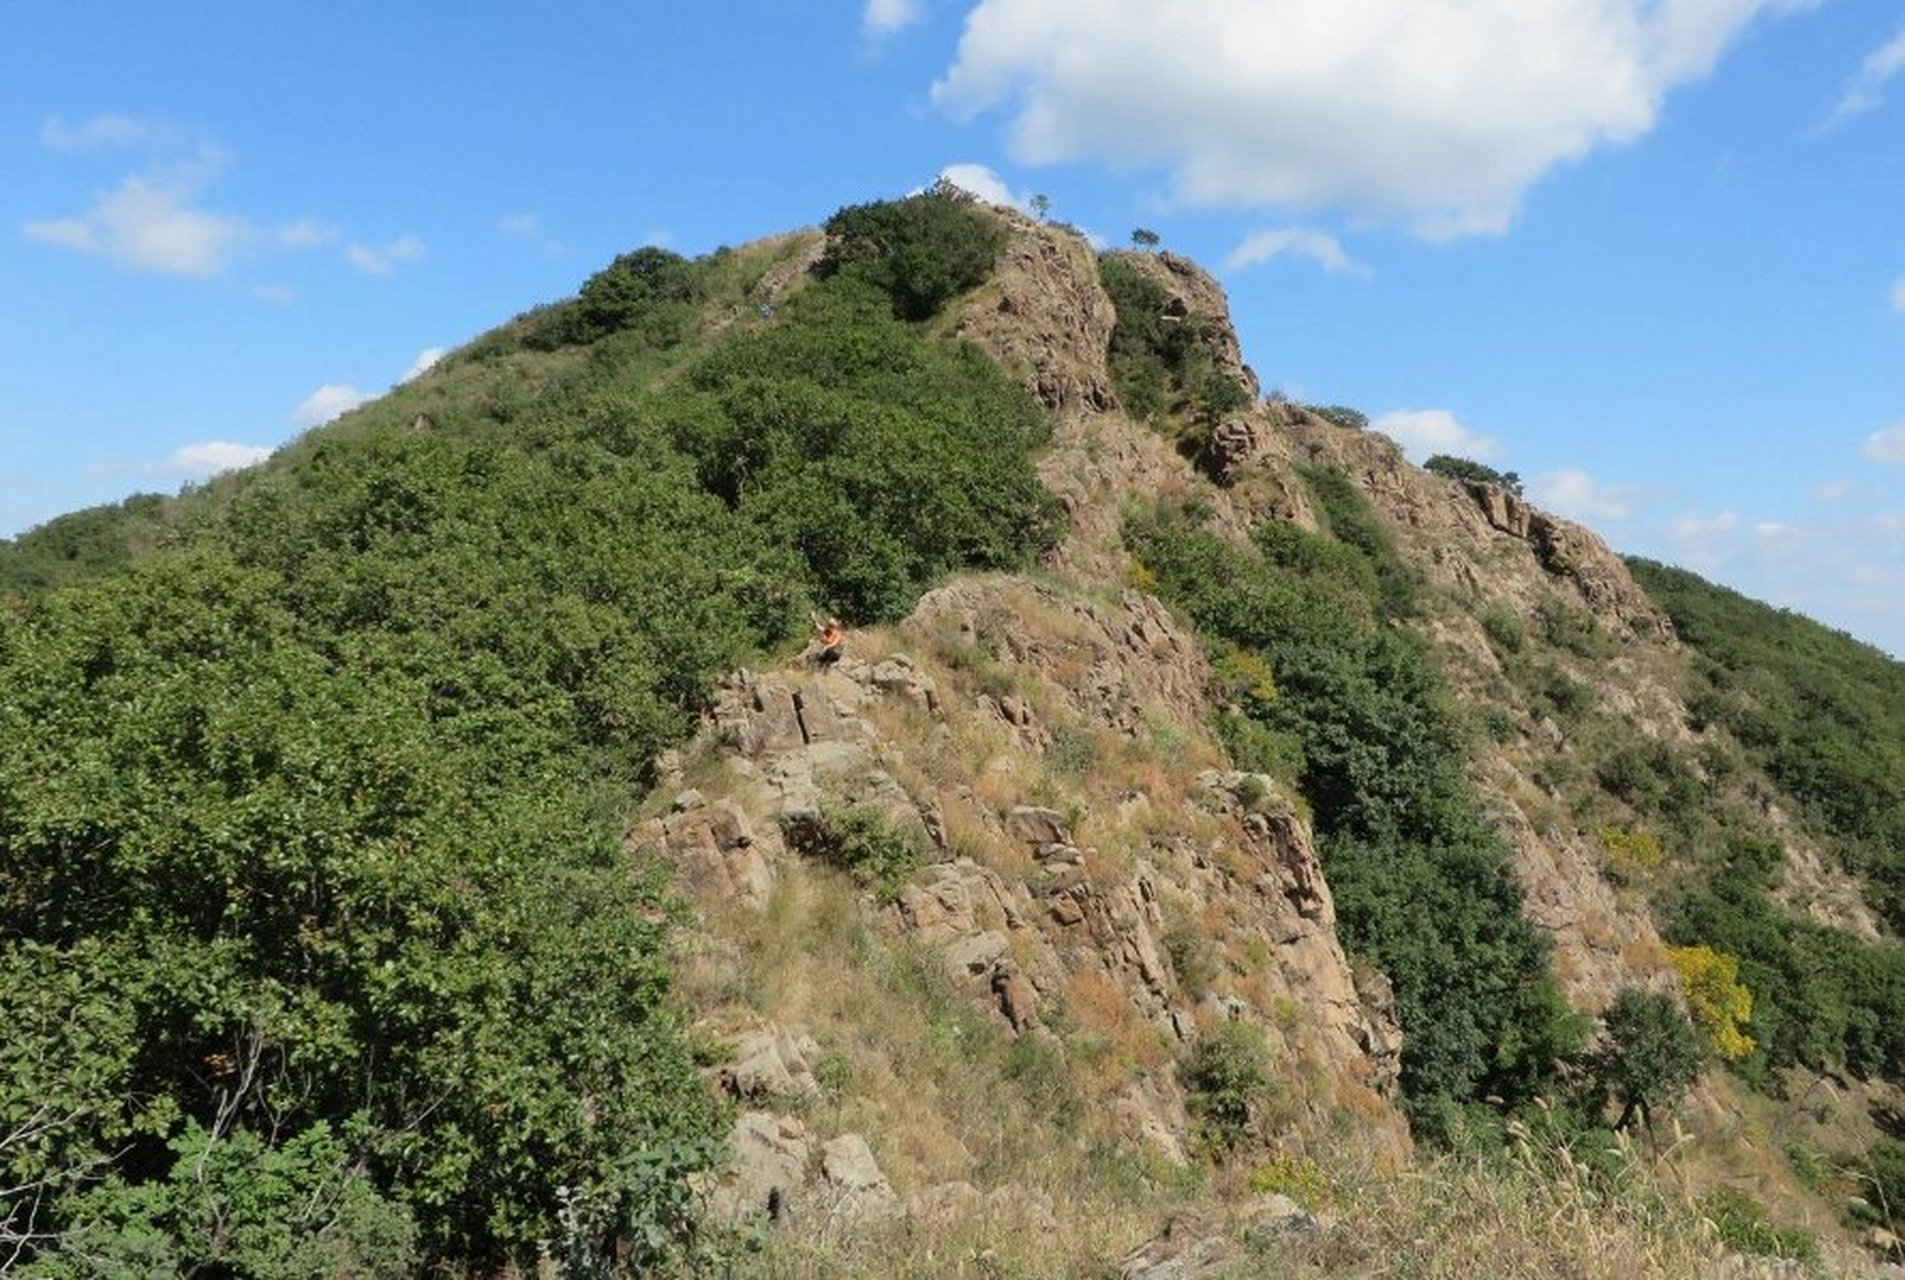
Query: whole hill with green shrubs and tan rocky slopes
0 189 1905 1276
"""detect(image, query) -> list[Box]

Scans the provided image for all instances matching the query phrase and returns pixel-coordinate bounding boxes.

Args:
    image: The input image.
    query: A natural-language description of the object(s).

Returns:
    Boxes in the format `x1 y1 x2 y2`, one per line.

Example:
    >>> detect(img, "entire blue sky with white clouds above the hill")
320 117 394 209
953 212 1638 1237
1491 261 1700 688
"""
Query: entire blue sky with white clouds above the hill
0 0 1905 653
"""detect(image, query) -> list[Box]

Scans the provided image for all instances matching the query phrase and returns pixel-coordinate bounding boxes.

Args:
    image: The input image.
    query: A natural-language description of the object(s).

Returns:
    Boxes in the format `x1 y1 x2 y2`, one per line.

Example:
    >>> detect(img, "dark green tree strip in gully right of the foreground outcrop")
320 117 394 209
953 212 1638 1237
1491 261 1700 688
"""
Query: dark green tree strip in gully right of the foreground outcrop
1126 493 1579 1131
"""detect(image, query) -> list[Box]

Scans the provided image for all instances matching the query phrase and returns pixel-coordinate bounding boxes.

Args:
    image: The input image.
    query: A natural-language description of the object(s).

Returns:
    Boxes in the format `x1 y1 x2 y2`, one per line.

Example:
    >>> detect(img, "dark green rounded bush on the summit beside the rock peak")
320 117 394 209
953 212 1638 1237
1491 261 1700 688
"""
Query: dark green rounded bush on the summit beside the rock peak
819 183 1006 320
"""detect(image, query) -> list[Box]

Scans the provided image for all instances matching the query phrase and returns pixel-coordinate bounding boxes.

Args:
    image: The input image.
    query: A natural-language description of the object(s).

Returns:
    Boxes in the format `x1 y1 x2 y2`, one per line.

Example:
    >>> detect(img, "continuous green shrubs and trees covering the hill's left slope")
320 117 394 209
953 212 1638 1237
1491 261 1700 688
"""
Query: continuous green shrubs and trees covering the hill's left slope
0 227 1055 1274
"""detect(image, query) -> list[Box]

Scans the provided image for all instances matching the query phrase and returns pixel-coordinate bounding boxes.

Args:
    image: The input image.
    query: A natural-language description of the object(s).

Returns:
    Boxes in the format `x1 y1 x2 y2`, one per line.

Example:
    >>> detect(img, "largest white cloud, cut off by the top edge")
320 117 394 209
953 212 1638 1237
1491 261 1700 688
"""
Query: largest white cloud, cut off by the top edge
933 0 1812 236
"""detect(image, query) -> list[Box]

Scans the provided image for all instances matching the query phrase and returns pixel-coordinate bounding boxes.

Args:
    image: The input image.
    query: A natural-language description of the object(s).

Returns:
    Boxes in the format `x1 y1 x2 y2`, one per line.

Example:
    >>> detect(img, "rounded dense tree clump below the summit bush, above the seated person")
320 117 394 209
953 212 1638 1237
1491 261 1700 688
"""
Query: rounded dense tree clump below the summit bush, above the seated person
661 274 1057 623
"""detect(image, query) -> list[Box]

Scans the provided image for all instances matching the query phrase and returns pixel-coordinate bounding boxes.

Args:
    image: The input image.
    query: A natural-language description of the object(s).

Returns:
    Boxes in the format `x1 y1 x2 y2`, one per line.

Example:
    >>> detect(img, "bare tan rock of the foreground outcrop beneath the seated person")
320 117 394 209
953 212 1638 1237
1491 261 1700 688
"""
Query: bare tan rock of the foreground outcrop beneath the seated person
647 577 1406 1165
